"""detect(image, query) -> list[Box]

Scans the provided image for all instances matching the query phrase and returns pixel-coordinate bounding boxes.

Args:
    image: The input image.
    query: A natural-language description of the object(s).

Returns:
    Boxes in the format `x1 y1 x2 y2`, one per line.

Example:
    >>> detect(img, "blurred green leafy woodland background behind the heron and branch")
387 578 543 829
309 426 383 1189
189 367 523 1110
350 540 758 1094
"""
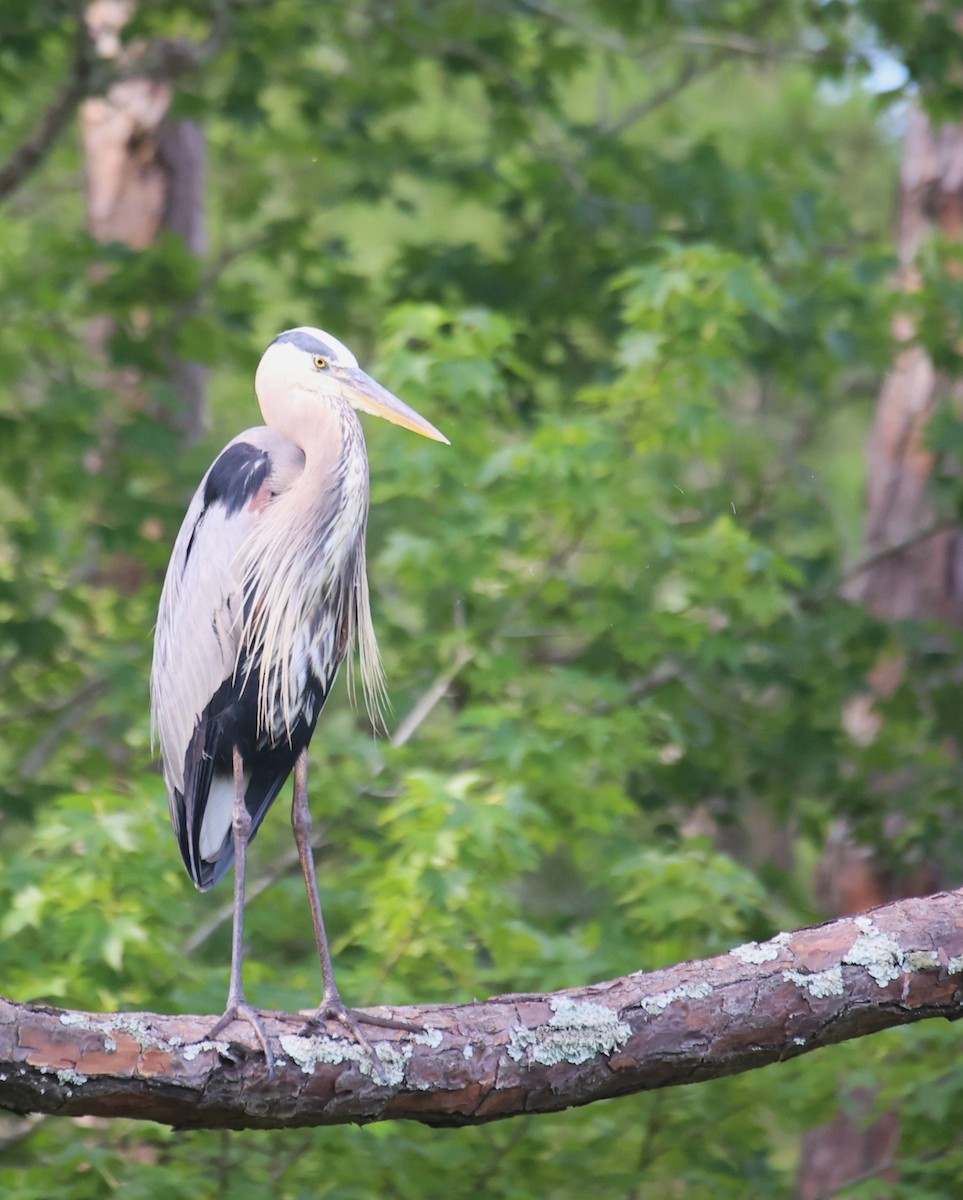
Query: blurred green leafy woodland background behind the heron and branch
0 0 963 1200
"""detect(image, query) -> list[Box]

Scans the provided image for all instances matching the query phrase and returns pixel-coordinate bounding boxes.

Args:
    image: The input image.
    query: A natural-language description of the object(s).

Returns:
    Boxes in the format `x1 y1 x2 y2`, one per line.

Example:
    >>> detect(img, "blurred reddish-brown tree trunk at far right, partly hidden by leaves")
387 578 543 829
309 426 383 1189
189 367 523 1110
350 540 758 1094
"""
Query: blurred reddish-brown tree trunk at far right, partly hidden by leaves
797 108 963 1200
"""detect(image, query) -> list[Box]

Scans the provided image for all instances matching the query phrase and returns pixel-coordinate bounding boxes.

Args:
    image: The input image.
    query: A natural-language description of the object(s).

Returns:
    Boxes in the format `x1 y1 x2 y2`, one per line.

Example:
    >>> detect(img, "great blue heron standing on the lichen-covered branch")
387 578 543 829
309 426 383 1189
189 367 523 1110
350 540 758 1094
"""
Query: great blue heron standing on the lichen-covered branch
151 326 448 1067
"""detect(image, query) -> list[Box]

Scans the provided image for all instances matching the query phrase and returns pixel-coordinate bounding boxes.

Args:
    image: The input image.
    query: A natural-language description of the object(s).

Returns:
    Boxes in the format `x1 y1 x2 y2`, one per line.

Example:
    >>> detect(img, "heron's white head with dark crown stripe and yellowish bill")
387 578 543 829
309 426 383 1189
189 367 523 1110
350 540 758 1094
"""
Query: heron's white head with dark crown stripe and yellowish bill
255 325 448 444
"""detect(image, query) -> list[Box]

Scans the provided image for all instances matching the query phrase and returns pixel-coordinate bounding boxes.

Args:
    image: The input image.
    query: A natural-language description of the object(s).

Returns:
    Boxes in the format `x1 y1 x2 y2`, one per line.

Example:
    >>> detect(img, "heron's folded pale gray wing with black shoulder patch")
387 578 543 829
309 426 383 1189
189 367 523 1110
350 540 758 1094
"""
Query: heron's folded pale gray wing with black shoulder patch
151 427 304 874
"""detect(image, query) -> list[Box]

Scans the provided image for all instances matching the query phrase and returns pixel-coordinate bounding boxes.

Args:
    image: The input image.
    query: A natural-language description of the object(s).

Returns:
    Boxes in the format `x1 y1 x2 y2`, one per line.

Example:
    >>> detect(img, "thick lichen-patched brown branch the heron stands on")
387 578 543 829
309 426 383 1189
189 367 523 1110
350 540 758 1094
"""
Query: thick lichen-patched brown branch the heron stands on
0 892 963 1129
